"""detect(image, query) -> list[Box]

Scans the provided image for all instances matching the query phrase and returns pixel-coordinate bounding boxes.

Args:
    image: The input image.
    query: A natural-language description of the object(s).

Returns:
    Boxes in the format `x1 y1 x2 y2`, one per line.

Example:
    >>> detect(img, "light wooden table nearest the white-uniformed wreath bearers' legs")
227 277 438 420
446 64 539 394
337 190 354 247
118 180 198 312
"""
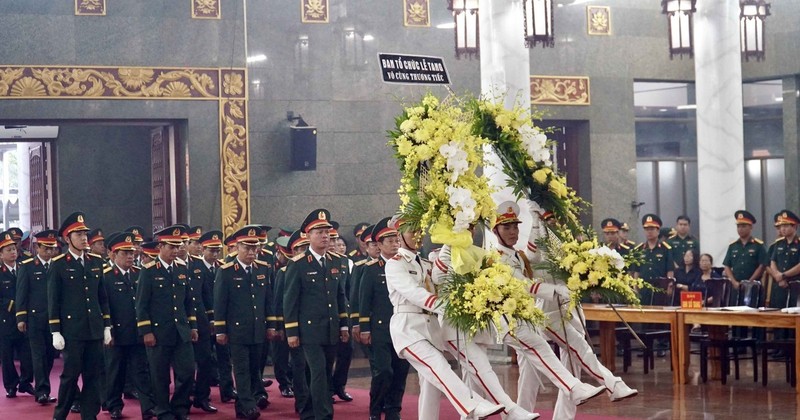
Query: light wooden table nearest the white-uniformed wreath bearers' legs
581 304 688 384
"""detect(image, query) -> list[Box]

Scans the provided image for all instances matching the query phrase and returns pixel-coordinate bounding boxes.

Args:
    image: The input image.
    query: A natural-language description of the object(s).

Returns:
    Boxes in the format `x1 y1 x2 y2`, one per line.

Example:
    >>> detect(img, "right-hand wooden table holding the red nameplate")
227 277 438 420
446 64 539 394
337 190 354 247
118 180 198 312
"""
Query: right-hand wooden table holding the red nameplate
672 309 800 394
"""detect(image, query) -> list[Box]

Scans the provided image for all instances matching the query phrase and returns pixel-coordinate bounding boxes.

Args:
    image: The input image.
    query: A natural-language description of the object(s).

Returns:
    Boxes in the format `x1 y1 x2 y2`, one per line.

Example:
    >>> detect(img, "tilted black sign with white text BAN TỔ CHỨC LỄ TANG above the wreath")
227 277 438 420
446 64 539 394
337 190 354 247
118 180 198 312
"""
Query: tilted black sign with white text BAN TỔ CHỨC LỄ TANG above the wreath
378 53 450 85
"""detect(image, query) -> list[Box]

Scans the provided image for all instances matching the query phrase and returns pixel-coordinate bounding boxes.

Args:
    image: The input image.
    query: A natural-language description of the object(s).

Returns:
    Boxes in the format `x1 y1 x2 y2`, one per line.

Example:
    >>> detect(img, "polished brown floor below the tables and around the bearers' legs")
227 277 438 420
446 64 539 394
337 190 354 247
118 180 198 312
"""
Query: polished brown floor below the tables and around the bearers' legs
336 344 800 420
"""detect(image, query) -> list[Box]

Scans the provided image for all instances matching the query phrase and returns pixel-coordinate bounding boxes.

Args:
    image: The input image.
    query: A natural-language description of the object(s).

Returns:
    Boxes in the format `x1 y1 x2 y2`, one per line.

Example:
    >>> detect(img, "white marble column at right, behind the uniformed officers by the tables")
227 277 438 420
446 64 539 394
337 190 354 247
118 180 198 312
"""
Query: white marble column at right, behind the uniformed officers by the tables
694 0 745 266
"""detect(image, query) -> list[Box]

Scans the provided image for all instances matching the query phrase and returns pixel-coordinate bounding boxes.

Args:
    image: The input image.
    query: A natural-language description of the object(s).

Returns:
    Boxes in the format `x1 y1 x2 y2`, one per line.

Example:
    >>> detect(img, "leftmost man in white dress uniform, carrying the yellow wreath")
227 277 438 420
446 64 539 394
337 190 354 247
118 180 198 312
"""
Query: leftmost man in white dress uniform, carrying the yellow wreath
386 218 504 419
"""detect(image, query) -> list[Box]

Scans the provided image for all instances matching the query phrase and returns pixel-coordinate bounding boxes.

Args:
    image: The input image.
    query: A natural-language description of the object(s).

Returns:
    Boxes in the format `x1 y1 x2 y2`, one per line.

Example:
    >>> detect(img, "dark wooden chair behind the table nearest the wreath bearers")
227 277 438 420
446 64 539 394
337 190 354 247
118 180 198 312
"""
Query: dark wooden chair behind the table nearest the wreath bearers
616 277 675 374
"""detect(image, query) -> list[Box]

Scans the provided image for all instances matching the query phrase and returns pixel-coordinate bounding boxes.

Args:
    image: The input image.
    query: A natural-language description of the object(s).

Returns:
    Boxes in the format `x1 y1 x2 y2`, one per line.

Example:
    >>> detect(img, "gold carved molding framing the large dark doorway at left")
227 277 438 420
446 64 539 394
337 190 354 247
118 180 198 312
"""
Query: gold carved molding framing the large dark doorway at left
0 65 250 235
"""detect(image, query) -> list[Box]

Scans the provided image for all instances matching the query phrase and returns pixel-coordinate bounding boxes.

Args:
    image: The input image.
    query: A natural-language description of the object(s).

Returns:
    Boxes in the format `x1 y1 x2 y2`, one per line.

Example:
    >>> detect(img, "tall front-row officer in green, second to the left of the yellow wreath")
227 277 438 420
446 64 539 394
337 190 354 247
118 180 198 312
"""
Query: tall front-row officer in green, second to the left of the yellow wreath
283 209 350 420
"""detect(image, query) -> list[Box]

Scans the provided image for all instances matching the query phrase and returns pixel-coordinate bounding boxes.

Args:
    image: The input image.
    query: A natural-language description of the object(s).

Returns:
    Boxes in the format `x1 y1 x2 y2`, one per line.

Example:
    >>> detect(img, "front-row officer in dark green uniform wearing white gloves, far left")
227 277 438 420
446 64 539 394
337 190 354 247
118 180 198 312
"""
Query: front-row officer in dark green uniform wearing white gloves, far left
47 212 111 420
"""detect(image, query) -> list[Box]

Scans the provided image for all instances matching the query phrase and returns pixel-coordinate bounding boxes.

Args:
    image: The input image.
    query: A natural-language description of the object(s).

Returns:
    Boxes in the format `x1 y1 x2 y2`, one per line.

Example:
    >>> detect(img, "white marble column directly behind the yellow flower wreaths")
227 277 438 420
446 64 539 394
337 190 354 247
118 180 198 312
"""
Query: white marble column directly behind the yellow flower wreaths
478 0 531 249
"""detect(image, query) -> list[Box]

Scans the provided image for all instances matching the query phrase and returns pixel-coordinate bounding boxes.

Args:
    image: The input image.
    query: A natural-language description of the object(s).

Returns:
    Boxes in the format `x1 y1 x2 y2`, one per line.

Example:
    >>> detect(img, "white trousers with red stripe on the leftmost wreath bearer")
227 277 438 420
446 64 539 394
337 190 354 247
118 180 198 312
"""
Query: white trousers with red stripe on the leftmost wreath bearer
400 340 485 419
